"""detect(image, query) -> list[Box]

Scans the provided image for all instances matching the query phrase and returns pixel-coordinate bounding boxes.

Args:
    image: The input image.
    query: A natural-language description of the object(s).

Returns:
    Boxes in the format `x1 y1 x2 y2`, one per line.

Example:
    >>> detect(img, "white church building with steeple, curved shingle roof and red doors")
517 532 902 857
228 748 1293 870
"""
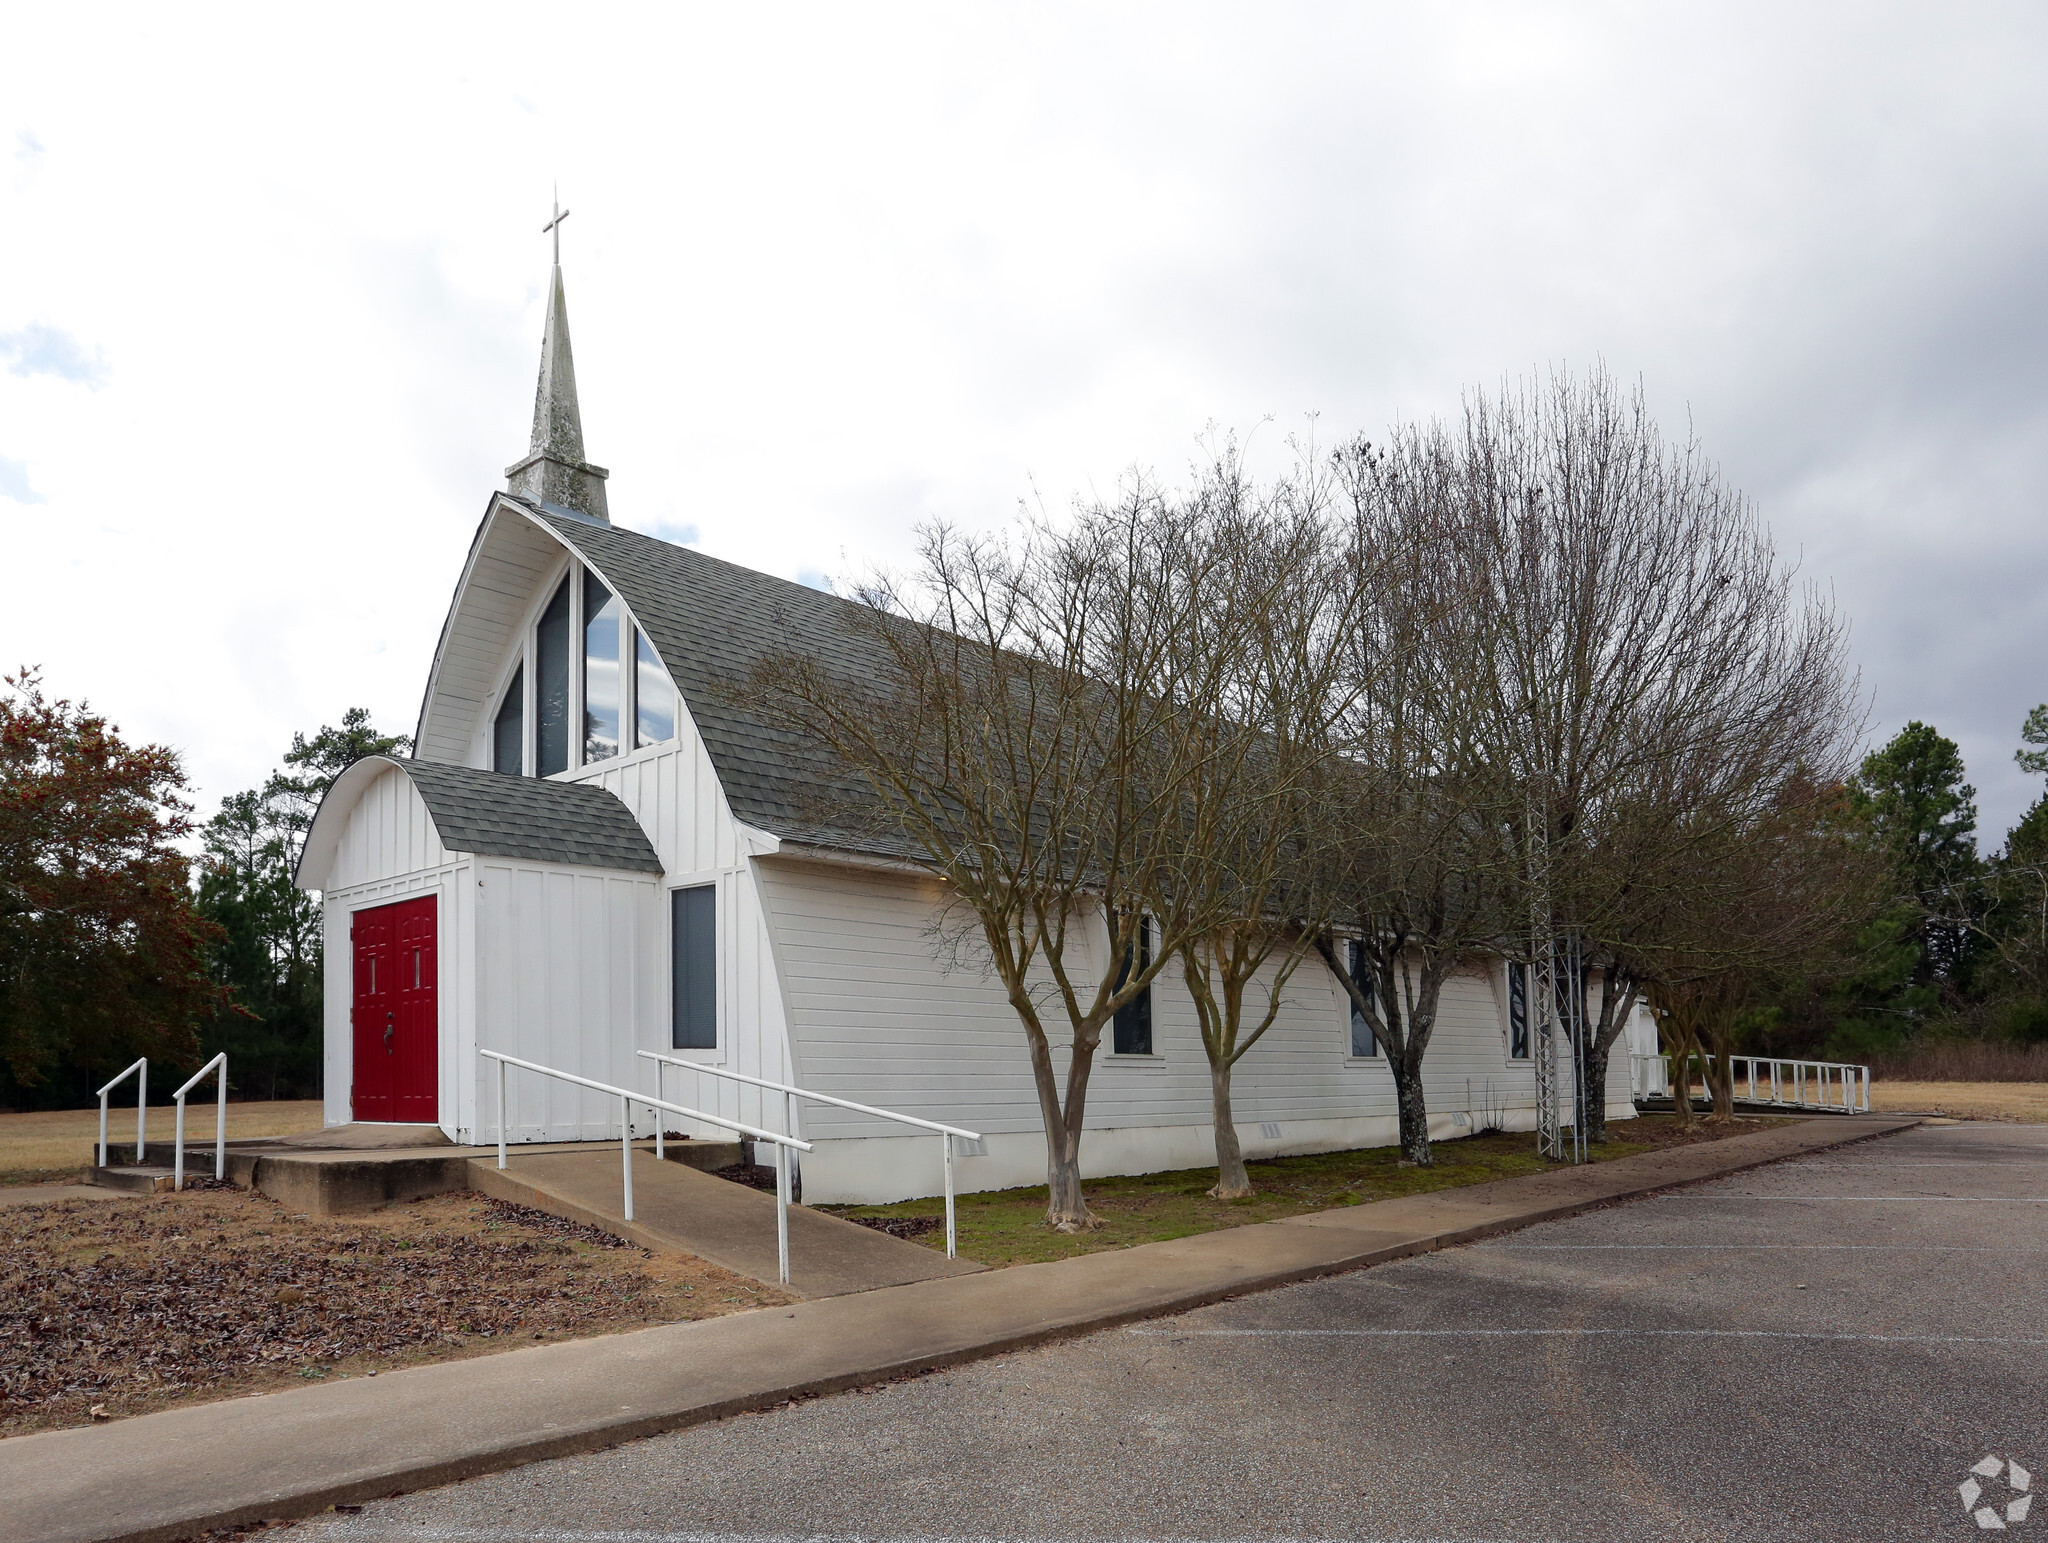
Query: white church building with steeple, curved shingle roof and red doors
299 246 1655 1201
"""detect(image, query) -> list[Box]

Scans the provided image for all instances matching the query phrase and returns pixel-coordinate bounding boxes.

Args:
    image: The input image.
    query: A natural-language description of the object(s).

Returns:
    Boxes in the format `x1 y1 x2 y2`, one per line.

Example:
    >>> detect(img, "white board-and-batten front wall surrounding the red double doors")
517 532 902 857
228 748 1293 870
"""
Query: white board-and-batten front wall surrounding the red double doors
319 766 477 1137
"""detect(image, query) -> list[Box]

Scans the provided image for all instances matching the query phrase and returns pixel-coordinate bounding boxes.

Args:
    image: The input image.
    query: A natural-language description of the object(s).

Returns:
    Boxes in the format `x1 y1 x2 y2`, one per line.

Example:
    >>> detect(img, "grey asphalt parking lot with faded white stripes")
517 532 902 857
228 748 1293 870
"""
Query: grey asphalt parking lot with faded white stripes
297 1125 2048 1543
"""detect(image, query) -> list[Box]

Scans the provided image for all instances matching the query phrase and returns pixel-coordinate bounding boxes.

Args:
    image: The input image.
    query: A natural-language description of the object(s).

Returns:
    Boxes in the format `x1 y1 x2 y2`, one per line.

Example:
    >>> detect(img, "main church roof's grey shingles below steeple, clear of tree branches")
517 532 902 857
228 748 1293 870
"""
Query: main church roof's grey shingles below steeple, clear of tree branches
520 494 909 857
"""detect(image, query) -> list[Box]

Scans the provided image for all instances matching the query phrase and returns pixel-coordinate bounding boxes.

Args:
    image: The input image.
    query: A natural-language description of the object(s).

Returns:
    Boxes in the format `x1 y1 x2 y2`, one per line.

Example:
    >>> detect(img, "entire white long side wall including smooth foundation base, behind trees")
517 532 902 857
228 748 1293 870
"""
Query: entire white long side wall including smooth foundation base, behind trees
756 859 1632 1201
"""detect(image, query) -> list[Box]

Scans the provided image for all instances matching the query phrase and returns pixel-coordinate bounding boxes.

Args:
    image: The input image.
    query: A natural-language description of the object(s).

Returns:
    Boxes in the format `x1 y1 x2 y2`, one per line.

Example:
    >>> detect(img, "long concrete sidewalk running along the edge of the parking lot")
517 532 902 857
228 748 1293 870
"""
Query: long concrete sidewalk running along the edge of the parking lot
0 1117 1917 1543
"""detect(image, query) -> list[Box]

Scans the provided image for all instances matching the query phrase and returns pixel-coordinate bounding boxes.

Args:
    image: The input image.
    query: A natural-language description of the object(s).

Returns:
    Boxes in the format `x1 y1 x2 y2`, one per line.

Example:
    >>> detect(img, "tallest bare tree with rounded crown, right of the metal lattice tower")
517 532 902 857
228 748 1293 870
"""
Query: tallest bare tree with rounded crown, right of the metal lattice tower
1446 373 1860 1139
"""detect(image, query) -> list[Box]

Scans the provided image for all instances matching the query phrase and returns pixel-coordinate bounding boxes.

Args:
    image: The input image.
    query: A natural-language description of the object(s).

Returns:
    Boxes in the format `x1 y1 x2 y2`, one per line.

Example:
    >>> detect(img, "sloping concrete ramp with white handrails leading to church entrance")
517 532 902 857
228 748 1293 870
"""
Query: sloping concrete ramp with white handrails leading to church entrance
469 1145 985 1297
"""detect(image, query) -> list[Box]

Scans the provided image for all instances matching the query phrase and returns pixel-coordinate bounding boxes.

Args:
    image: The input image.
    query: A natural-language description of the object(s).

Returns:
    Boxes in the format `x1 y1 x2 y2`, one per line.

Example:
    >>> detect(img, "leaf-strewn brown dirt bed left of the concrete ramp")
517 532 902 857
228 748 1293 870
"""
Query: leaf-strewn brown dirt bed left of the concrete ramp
0 1186 788 1436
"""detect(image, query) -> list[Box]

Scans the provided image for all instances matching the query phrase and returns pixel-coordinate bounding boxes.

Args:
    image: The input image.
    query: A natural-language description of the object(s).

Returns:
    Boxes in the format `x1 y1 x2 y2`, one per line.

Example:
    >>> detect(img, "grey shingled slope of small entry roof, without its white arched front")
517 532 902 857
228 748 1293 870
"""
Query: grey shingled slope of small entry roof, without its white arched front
399 760 662 873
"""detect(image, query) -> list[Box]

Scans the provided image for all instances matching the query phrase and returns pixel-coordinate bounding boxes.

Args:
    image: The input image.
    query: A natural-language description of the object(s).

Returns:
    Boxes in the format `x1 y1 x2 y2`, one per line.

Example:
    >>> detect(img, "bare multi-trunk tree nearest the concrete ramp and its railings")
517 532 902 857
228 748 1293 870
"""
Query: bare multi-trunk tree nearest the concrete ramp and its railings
752 479 1245 1232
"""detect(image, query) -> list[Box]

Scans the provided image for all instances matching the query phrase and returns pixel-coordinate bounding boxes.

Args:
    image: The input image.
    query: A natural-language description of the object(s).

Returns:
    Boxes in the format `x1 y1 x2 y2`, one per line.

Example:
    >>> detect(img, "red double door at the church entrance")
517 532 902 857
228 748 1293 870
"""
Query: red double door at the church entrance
350 895 440 1125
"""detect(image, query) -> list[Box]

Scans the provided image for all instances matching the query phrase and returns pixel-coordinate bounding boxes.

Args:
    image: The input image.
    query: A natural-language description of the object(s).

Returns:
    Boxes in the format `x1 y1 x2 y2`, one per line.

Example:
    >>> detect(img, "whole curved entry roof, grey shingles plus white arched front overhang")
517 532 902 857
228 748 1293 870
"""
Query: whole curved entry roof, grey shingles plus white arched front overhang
295 756 662 889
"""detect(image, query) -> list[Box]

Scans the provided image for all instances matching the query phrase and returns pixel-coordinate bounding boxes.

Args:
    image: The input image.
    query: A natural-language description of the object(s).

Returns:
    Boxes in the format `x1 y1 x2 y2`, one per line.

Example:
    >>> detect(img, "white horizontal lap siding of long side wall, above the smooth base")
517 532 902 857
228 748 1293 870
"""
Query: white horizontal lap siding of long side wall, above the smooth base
760 861 1626 1137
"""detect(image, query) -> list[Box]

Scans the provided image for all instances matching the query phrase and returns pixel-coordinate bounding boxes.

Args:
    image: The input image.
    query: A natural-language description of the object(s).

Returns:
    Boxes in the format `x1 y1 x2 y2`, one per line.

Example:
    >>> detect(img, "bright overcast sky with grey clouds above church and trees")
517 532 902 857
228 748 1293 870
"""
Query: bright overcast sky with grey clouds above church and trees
0 0 2048 844
